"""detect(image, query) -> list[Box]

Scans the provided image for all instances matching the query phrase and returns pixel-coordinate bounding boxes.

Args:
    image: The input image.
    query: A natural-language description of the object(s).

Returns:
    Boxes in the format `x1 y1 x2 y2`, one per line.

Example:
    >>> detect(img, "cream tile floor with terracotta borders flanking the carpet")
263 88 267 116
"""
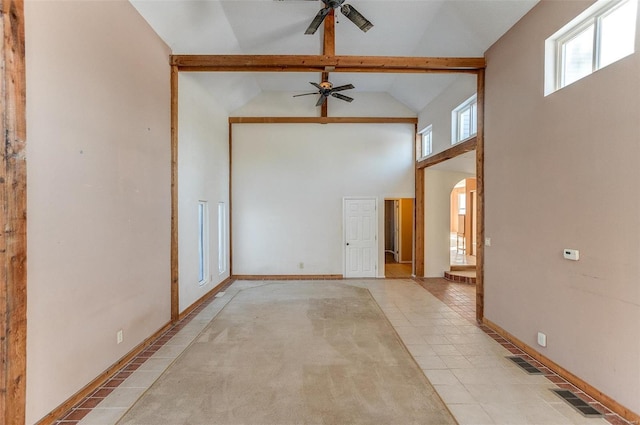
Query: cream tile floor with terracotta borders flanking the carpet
55 279 627 425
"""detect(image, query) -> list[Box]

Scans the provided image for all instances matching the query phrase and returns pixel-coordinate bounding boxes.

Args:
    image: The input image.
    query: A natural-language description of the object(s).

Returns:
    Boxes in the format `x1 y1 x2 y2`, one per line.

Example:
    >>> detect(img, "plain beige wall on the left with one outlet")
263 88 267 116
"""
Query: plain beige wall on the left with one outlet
25 1 170 424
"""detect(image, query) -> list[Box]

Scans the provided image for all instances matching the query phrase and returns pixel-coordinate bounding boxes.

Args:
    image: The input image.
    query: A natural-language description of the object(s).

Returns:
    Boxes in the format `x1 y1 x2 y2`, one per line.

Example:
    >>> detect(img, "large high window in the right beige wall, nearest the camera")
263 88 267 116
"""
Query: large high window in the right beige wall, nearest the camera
545 0 638 95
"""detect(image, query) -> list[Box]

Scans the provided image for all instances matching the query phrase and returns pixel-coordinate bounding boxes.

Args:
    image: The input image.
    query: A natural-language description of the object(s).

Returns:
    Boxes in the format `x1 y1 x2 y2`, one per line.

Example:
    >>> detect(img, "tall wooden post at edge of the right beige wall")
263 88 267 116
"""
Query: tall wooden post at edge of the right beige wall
476 69 485 323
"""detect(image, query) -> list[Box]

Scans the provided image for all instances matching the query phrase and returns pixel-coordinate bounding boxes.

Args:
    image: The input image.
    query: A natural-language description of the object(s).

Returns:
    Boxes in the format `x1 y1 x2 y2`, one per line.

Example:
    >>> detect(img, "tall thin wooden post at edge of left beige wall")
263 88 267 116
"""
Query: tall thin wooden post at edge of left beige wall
171 65 180 323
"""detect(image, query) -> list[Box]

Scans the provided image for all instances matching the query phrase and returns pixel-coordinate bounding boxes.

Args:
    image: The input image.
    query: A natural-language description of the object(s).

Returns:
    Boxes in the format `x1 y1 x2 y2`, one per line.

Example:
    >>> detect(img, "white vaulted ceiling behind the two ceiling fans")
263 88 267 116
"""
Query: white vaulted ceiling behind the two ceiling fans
130 0 538 114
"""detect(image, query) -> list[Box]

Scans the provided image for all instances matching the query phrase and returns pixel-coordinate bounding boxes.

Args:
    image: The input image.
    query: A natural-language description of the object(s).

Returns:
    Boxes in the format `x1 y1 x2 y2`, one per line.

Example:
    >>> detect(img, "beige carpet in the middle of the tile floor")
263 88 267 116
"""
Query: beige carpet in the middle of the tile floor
119 282 456 425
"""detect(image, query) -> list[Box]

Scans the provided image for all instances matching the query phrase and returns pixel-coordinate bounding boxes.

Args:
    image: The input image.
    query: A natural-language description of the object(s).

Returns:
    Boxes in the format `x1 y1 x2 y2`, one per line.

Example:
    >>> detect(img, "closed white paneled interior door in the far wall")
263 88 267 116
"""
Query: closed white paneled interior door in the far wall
344 198 378 277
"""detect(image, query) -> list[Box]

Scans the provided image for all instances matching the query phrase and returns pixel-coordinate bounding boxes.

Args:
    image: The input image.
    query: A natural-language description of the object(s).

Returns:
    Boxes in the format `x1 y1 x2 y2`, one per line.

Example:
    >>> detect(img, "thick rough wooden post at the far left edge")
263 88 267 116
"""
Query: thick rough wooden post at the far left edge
0 0 27 425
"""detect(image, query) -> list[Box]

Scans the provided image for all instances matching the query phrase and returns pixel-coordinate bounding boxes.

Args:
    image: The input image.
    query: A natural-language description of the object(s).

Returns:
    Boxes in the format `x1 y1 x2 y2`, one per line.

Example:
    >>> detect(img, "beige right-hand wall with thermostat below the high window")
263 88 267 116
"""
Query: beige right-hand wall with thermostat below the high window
485 1 640 412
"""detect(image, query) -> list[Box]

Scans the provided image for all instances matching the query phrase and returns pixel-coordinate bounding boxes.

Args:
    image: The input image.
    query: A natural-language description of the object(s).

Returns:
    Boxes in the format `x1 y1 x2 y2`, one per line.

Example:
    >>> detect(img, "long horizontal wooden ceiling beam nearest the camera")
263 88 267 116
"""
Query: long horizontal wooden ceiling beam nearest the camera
171 55 486 73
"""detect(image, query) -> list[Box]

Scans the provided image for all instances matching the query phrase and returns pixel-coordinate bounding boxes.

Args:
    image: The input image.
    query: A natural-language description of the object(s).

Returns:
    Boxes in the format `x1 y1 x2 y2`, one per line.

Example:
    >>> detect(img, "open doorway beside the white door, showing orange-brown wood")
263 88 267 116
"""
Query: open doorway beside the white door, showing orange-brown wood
384 198 414 278
